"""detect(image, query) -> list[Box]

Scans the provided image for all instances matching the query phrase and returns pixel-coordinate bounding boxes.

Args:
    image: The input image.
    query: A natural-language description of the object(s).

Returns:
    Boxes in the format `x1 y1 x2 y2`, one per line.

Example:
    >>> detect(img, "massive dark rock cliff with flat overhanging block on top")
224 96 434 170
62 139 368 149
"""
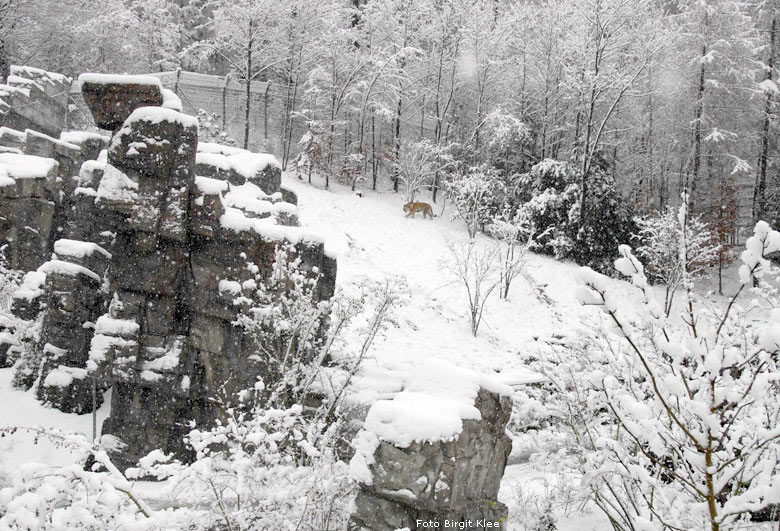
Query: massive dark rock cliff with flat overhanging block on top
0 69 336 469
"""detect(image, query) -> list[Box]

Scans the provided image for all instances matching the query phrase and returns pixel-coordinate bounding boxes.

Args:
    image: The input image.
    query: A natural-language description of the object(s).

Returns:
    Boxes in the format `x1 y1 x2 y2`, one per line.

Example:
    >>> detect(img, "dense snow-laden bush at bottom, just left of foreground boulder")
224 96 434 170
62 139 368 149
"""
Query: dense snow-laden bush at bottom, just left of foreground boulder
127 402 355 531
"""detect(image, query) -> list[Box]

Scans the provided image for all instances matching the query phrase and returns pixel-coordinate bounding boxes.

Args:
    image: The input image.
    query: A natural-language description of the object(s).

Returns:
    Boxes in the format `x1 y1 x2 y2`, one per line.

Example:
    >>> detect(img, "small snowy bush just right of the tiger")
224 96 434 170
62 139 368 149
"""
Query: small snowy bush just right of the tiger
447 166 503 239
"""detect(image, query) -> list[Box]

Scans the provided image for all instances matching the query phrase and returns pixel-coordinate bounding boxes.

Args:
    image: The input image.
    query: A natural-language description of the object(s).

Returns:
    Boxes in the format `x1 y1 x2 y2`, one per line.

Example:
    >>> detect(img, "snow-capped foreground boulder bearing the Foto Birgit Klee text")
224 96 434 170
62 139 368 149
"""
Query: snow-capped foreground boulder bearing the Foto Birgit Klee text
349 362 512 531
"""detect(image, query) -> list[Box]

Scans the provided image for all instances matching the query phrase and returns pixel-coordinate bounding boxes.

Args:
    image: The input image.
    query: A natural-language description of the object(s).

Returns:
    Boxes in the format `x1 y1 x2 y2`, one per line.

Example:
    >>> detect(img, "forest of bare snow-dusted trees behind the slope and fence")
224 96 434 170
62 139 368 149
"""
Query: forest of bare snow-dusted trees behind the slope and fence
0 0 780 239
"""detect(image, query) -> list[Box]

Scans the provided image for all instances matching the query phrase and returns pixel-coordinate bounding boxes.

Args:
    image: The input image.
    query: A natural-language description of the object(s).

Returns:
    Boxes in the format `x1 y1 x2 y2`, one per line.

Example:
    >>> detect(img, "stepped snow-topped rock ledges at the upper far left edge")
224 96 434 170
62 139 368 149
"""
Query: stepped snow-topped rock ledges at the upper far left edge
0 66 108 271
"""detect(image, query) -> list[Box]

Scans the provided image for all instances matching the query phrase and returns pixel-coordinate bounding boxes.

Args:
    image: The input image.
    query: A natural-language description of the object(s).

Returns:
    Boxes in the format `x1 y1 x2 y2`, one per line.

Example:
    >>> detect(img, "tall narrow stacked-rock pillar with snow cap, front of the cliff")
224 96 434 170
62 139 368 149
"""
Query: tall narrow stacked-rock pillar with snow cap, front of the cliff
85 107 198 467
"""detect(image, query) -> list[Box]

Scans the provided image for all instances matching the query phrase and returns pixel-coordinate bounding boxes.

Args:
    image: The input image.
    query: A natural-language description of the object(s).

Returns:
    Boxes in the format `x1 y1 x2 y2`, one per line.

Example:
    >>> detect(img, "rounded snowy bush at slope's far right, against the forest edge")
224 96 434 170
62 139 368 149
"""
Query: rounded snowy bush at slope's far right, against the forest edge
634 194 719 316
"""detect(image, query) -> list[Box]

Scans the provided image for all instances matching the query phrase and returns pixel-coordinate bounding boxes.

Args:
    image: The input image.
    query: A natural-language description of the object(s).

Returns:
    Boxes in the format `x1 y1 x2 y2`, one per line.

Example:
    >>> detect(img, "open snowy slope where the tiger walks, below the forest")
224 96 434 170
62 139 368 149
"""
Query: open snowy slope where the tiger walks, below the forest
283 174 632 384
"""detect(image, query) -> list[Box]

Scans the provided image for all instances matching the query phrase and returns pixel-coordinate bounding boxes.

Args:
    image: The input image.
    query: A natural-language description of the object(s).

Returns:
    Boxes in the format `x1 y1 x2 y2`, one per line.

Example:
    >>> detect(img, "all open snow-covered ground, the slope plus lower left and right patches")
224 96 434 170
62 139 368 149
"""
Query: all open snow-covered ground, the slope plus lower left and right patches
0 174 748 531
